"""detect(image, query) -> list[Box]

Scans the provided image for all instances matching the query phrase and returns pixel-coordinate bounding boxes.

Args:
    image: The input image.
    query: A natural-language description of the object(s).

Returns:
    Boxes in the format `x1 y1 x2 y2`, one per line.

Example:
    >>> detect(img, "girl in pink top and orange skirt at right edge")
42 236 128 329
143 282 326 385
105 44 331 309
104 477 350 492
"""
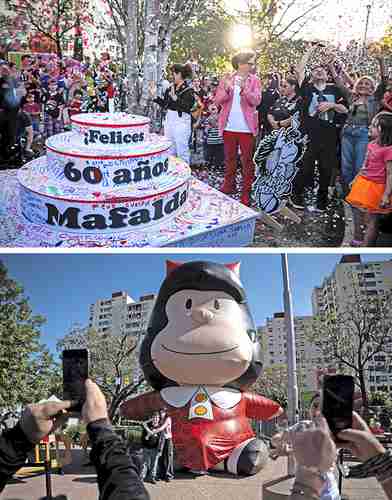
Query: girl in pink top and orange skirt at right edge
346 112 392 247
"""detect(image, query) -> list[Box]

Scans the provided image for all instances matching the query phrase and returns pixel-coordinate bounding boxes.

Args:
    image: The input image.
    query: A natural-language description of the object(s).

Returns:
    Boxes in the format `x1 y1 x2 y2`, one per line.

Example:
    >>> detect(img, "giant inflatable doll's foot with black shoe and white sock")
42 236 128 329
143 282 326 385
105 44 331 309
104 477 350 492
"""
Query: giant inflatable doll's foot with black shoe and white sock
227 438 268 476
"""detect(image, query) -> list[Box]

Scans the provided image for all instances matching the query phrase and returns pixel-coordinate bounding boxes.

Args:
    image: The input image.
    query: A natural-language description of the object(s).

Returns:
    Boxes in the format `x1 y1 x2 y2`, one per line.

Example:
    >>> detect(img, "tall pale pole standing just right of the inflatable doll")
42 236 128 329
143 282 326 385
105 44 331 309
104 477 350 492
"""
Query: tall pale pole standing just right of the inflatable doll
281 254 298 476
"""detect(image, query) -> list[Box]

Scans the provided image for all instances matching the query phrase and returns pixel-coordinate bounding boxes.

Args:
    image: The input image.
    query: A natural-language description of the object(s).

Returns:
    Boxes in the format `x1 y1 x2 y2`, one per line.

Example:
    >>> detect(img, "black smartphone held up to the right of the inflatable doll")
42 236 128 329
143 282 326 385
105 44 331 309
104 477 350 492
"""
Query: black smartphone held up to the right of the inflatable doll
321 375 354 435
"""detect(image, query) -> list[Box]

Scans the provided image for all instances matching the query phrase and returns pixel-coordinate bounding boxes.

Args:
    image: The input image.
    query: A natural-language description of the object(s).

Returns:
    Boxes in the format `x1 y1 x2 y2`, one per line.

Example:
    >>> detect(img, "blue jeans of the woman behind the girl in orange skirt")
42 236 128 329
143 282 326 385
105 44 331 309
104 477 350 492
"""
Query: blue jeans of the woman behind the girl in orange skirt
342 125 369 186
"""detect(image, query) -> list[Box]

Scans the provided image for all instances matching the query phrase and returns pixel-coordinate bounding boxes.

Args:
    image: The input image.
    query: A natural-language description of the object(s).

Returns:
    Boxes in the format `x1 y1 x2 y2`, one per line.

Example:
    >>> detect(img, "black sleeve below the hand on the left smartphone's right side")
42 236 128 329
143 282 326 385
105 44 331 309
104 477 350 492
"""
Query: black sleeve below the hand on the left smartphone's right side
87 420 150 500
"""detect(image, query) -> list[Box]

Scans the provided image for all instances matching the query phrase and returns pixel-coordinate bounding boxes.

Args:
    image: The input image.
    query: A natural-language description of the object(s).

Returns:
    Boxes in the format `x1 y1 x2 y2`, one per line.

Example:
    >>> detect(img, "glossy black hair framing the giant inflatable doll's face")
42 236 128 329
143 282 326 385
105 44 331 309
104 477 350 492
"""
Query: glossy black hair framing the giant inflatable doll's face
139 261 262 390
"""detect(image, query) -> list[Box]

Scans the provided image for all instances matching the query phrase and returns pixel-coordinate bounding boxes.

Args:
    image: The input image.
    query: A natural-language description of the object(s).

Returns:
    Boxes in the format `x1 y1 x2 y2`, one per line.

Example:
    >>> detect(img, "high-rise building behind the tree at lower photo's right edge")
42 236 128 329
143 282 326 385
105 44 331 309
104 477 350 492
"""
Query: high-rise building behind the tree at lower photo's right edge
312 255 392 392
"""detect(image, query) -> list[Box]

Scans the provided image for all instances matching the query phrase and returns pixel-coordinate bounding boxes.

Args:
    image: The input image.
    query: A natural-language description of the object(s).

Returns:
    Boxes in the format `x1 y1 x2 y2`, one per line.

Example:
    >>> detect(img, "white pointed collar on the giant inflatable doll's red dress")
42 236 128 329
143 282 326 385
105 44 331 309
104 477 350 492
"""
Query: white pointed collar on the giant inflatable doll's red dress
160 385 242 410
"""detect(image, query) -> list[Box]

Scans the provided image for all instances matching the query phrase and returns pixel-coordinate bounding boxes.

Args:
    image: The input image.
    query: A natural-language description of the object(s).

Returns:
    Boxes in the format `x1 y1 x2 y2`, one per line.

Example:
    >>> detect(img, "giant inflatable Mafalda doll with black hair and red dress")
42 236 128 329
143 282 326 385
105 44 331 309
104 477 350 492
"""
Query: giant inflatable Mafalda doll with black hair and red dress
121 262 283 475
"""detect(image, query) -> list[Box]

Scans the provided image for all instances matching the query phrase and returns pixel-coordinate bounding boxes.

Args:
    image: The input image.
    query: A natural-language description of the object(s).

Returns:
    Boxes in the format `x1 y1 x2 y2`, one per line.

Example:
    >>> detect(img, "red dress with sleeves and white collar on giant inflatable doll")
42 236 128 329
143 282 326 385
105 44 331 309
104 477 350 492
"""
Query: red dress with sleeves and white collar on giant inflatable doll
121 386 280 470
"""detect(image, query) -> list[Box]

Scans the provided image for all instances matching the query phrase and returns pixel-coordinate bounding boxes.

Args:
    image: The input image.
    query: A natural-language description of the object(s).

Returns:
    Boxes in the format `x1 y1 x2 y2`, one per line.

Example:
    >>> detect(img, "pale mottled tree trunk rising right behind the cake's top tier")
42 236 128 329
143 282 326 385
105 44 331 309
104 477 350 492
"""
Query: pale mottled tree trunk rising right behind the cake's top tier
140 0 159 114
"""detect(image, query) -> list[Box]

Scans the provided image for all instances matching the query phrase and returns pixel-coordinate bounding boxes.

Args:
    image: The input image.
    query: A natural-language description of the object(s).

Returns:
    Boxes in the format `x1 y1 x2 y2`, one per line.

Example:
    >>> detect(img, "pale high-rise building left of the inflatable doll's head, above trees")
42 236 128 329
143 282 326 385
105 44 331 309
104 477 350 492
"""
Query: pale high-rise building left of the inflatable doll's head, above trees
89 291 156 335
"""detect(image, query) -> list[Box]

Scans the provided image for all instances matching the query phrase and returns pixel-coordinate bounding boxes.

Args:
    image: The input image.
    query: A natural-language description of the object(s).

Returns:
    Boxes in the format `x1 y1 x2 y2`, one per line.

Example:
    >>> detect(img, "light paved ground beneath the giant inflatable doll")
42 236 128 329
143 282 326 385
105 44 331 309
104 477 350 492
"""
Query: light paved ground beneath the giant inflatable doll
1 450 385 500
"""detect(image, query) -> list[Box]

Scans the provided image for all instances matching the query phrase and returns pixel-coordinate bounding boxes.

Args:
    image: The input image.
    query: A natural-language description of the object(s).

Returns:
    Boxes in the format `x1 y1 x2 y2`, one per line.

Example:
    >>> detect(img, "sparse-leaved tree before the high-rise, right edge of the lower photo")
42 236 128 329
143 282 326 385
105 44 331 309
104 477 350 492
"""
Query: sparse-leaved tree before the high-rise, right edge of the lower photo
310 286 392 408
